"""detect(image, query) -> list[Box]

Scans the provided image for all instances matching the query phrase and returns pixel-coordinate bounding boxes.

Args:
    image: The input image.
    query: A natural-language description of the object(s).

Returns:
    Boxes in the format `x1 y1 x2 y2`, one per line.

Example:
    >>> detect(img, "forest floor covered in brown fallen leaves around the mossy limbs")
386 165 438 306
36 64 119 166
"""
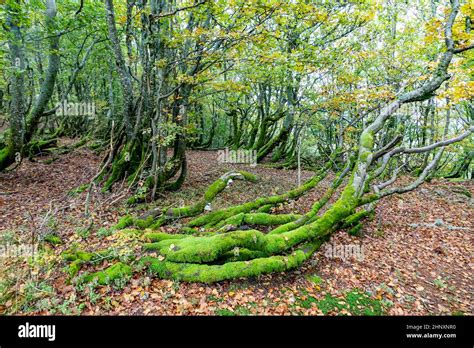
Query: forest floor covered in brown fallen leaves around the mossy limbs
0 139 474 315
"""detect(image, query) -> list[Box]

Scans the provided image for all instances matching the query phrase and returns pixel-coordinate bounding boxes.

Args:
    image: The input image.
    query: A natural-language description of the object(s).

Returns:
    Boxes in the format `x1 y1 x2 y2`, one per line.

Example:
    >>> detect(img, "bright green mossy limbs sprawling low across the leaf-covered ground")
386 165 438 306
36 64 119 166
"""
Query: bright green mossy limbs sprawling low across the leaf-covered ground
65 166 374 284
